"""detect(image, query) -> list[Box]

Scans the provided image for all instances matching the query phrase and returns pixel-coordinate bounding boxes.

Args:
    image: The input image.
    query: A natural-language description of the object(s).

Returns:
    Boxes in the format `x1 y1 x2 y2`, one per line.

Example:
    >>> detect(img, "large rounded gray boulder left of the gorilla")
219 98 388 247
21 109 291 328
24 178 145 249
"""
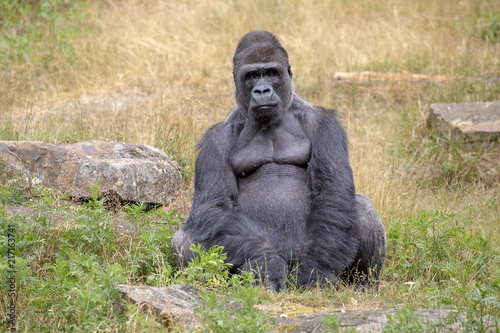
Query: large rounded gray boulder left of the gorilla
0 141 182 204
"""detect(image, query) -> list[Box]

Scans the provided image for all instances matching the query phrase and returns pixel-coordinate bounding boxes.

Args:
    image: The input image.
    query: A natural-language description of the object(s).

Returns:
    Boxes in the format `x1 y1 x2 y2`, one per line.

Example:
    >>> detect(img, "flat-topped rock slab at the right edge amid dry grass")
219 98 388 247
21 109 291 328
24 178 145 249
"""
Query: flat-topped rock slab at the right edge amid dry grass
428 101 500 143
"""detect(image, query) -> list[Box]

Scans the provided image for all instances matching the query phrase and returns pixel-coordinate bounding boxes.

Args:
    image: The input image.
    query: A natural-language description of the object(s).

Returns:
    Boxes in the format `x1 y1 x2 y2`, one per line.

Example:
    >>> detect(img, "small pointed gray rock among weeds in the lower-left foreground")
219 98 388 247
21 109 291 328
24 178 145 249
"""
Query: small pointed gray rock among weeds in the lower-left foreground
118 285 201 329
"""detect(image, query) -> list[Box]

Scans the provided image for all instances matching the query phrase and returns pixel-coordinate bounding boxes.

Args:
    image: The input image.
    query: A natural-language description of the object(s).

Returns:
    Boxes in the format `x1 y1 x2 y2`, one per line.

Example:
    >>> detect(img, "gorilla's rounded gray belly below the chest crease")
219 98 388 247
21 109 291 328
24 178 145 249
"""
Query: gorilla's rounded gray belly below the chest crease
238 163 310 238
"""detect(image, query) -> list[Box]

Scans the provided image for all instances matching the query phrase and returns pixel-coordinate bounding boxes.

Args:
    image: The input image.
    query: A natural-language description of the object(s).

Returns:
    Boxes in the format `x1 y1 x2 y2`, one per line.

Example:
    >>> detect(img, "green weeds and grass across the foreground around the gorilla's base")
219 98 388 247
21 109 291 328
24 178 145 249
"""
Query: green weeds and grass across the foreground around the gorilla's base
0 171 500 332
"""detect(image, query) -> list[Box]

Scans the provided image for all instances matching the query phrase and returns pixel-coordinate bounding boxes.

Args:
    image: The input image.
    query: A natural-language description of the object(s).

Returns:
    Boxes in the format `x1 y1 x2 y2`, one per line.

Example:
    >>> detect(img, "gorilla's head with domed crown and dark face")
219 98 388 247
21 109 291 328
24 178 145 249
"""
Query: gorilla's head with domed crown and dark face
233 30 293 127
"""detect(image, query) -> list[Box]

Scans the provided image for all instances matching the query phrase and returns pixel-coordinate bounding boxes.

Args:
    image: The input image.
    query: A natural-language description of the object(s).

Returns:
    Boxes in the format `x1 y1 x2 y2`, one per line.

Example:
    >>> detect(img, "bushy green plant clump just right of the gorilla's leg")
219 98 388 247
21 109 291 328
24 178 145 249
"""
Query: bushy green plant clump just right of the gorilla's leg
385 212 499 284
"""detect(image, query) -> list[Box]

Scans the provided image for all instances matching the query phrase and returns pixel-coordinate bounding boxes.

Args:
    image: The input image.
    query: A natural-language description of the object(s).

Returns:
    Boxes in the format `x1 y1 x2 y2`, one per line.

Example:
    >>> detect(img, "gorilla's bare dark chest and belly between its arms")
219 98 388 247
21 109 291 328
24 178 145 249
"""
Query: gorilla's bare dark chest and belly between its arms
231 125 311 228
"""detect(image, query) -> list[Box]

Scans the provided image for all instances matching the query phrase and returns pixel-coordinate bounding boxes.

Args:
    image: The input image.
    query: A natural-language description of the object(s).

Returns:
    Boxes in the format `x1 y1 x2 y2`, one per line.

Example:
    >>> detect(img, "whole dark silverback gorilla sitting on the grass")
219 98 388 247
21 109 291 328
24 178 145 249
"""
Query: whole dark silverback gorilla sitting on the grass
173 30 385 291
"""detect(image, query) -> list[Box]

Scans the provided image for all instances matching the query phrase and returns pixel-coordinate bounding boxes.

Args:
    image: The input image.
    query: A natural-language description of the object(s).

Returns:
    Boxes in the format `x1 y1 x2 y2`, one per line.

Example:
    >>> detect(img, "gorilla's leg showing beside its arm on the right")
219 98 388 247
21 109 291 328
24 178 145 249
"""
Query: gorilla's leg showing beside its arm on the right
342 194 385 287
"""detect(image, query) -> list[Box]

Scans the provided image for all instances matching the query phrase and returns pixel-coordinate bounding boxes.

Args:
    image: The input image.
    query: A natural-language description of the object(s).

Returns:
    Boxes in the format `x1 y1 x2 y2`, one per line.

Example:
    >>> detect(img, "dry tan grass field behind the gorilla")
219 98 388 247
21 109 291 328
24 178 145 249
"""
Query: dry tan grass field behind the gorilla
0 0 500 316
